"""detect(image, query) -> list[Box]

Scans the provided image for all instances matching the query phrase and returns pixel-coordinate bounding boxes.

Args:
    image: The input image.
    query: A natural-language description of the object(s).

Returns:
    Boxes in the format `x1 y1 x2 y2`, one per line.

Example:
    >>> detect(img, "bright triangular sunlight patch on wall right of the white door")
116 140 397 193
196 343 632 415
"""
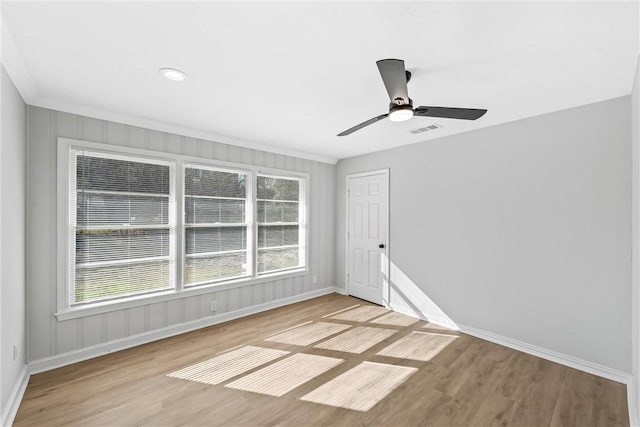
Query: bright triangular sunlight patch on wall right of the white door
381 254 460 330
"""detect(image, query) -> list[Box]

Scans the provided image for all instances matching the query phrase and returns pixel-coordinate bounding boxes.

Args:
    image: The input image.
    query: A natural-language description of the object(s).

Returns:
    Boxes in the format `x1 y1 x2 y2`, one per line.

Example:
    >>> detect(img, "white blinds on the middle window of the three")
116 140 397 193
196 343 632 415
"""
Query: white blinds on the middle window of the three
184 165 251 286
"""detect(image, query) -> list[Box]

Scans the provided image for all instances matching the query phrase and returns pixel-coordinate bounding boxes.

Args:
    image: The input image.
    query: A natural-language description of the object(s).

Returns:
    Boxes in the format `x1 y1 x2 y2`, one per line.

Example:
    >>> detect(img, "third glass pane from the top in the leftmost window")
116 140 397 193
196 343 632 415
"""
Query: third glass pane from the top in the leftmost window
76 229 171 264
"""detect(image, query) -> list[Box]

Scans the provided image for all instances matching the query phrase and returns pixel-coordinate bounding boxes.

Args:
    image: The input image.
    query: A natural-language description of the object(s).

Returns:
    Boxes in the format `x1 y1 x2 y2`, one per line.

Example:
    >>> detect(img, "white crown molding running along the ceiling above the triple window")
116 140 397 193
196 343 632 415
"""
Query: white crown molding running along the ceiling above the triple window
33 97 338 165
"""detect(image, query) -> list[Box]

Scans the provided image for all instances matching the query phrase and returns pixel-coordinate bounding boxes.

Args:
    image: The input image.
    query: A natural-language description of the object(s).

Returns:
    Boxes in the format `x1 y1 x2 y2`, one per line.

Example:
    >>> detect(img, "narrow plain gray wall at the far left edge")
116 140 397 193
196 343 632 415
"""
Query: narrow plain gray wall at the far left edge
0 67 27 419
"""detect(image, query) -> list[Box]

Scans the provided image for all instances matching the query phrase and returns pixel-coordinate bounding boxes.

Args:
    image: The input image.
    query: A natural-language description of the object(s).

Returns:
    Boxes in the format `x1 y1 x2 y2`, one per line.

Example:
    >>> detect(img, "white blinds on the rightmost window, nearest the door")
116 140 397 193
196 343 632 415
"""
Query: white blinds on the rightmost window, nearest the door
257 175 305 274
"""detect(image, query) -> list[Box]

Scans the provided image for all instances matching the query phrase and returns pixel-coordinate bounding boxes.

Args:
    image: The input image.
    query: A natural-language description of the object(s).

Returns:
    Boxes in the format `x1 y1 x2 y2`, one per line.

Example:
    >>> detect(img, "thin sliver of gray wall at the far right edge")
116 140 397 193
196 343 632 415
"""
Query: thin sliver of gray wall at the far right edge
629 56 640 422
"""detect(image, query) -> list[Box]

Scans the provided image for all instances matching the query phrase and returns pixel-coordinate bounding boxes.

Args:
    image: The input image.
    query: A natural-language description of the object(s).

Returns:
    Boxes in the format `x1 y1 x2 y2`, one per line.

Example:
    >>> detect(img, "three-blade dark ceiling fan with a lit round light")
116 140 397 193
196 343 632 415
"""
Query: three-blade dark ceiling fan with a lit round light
338 59 487 136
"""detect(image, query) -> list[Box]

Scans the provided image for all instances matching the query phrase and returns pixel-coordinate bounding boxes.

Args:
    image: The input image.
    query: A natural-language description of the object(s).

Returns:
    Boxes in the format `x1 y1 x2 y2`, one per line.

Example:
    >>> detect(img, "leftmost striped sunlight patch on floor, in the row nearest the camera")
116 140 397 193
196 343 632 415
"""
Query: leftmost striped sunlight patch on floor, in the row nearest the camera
167 345 289 385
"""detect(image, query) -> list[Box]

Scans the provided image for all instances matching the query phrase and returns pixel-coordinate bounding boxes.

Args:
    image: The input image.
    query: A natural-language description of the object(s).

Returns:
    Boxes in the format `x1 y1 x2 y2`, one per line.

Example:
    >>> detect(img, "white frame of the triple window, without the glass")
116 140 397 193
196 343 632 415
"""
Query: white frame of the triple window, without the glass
55 137 311 321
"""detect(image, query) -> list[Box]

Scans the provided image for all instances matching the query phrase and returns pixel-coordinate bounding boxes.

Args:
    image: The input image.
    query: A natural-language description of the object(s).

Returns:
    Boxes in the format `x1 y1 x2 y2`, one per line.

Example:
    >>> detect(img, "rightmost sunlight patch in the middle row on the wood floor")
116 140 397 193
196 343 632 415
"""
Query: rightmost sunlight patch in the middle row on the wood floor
376 331 458 362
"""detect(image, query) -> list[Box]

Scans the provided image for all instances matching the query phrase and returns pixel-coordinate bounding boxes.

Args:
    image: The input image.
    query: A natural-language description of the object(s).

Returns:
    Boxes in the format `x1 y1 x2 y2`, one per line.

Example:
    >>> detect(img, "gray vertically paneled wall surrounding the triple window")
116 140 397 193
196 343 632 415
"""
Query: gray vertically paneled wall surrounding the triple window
27 106 335 361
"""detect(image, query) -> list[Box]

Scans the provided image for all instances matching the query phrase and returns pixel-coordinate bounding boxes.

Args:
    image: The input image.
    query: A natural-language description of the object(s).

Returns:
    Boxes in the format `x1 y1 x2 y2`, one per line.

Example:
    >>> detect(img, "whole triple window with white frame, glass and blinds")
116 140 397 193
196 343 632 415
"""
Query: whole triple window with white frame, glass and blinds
58 138 307 318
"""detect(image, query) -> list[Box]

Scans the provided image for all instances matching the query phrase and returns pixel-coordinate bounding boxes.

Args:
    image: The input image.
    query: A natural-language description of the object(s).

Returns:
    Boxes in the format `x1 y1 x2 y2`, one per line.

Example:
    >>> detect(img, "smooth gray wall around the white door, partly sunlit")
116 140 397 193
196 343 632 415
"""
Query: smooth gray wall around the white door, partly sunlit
336 97 631 372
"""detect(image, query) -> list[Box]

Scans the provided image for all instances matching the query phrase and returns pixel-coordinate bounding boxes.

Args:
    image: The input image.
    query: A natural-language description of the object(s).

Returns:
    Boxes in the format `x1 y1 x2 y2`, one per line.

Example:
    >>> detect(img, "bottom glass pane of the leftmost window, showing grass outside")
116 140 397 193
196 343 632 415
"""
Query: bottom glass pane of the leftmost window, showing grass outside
71 261 172 303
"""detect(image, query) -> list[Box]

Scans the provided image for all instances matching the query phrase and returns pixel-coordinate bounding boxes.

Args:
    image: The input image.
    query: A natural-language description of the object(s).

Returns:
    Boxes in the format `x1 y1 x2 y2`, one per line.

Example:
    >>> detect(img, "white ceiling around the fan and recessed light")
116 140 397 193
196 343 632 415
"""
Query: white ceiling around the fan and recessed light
2 1 639 162
